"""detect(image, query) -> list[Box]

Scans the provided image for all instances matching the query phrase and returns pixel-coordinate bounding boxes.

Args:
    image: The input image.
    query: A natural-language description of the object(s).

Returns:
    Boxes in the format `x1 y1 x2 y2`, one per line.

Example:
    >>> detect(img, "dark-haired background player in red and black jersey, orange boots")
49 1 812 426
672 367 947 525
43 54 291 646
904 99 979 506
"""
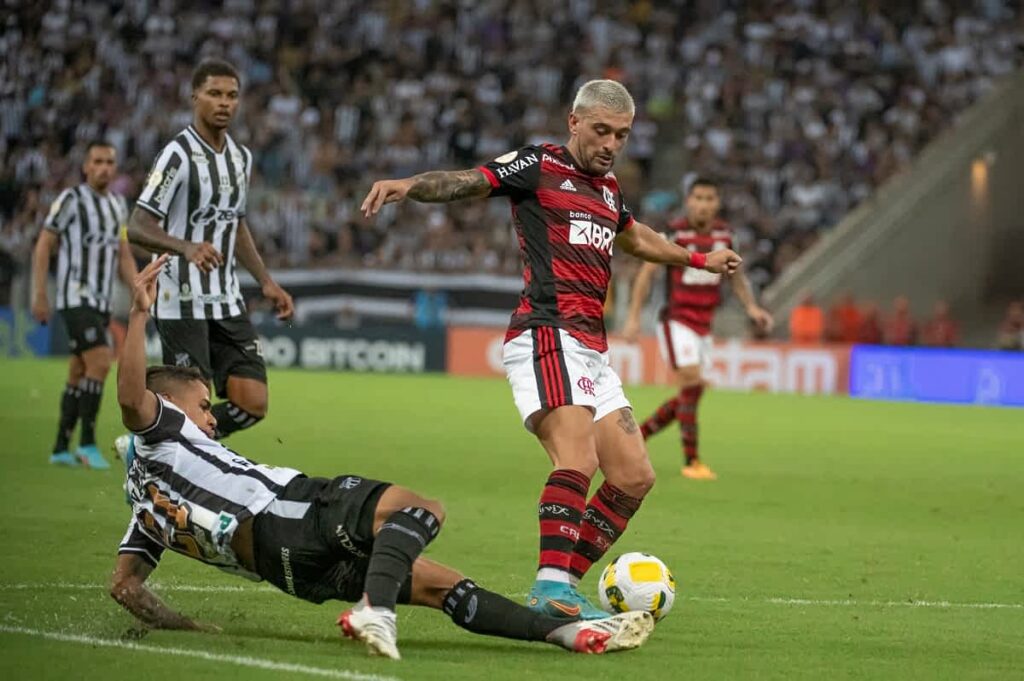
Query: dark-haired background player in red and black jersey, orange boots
623 178 772 480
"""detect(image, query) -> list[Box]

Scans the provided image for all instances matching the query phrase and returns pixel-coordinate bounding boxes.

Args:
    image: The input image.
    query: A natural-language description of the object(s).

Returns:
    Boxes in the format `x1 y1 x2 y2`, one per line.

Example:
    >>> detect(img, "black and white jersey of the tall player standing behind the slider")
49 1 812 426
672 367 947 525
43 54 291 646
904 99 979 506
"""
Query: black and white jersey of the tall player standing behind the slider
138 125 252 320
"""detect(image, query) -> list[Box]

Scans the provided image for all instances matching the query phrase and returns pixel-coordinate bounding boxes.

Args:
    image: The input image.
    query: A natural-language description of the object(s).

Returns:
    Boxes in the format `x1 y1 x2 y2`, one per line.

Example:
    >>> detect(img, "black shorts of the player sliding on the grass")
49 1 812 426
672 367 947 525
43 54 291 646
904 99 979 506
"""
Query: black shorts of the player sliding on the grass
253 475 411 603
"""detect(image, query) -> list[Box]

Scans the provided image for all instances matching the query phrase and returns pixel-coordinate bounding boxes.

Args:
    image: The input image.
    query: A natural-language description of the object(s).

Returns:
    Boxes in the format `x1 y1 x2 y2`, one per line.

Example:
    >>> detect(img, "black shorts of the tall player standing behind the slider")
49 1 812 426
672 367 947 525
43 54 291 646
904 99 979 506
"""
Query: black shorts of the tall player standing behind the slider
157 315 266 397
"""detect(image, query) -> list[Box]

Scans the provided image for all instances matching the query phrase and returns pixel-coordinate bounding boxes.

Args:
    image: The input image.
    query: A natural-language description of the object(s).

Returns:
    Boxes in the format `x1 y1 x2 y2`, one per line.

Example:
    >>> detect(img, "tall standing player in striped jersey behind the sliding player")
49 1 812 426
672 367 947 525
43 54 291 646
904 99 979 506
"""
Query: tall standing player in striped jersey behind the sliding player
128 59 294 437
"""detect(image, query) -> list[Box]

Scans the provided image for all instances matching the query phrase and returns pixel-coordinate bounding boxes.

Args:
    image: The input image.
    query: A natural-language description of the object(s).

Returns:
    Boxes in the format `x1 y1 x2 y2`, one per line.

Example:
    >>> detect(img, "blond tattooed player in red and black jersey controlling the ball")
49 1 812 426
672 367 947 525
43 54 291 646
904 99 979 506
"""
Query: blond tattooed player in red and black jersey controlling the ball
362 80 740 619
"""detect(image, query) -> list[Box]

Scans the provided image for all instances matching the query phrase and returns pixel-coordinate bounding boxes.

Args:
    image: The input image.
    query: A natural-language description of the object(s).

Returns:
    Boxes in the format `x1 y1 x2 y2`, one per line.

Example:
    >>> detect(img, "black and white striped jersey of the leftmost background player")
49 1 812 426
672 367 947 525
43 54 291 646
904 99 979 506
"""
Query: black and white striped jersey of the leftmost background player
43 182 128 312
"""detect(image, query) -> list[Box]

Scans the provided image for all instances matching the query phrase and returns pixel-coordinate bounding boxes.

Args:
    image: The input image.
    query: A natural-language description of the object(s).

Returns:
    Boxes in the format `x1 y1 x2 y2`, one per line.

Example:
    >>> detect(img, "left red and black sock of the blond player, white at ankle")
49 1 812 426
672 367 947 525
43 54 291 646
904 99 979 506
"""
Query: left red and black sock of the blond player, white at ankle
537 468 590 584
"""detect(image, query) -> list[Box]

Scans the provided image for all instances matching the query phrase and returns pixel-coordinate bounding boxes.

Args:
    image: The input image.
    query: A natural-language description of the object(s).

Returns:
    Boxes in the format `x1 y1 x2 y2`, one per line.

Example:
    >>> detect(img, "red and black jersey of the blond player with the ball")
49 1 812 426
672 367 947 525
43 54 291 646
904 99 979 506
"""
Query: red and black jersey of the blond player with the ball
479 144 633 352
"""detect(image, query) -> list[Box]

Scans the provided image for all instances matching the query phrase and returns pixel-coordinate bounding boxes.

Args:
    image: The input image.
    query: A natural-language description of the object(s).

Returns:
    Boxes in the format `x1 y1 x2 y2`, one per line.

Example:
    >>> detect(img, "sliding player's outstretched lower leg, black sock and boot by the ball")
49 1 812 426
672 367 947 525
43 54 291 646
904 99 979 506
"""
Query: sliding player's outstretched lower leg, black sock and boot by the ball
411 558 653 653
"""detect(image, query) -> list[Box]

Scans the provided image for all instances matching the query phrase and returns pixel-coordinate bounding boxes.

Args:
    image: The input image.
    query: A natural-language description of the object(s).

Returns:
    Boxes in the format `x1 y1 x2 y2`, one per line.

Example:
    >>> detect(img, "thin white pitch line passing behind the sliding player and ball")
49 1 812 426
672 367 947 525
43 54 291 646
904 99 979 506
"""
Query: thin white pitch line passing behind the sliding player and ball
0 582 1024 610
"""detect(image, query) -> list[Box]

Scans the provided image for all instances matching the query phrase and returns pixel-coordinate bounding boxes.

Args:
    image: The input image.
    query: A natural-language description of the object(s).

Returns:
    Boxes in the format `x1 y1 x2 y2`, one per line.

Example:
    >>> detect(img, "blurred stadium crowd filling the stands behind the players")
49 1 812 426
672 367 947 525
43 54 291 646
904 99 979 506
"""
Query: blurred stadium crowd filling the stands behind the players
0 0 1022 305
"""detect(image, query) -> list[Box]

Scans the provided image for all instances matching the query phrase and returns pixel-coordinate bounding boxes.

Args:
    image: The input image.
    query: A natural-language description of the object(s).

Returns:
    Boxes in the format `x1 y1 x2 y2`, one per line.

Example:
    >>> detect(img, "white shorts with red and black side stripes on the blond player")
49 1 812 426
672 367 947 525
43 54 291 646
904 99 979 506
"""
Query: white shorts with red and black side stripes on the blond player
502 327 630 431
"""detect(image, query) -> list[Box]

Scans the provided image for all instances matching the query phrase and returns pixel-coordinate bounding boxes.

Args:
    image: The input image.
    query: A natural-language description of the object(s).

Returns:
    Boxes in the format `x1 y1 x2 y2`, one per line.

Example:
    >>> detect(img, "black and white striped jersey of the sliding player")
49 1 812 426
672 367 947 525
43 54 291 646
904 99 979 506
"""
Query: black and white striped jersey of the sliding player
119 395 299 581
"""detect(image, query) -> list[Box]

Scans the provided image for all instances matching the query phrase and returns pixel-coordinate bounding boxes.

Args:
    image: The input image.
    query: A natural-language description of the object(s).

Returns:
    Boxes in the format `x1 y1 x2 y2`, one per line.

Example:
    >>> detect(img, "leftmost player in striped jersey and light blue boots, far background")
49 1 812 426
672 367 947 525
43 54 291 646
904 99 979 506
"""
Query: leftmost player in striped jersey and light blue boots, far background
32 141 136 468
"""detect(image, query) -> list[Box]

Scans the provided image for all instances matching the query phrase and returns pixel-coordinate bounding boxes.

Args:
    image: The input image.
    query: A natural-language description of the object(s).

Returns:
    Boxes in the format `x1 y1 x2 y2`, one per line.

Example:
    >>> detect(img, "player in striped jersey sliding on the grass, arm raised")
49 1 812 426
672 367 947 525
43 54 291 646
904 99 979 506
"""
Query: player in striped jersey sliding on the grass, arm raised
111 255 654 659
